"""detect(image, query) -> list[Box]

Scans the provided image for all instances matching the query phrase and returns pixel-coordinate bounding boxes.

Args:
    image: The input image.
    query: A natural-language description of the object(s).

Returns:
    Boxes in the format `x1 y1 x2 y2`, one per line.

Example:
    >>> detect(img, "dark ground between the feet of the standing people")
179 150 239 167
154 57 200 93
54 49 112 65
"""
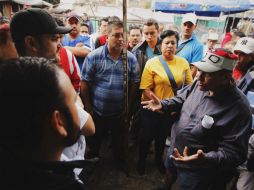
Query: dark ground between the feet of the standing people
85 139 176 190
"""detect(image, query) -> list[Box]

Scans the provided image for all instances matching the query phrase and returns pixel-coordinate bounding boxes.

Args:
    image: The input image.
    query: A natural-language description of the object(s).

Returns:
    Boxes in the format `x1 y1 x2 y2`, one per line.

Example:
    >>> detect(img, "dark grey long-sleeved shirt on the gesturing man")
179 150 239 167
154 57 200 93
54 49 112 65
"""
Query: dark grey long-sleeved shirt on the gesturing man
161 81 252 169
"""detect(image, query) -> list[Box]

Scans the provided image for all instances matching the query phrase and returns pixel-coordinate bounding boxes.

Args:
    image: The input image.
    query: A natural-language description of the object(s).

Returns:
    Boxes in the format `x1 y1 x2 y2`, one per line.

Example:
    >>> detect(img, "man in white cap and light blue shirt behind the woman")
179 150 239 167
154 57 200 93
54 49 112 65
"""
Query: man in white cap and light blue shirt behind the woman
176 13 203 78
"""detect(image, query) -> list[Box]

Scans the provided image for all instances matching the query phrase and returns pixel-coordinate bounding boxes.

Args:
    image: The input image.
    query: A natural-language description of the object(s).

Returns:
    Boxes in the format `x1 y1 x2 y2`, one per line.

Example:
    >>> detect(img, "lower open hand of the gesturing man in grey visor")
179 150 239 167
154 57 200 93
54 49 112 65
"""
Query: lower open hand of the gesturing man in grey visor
170 146 205 163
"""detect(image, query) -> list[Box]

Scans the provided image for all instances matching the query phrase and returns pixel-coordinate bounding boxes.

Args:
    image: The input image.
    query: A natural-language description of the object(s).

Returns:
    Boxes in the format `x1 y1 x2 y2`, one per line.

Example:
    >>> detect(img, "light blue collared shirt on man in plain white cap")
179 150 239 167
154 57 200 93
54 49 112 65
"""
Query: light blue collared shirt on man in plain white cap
176 34 203 64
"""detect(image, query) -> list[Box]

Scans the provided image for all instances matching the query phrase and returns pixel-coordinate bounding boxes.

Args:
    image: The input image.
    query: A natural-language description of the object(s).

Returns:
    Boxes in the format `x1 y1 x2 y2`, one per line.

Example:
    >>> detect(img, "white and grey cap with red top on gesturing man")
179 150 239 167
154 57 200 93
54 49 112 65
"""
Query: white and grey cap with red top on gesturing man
192 49 237 73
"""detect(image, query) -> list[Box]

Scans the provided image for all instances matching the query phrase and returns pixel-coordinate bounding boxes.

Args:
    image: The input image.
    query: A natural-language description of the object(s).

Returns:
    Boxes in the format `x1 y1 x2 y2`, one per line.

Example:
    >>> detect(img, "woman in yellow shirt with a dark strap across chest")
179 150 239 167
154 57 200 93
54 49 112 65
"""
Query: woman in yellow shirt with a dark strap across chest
137 30 192 175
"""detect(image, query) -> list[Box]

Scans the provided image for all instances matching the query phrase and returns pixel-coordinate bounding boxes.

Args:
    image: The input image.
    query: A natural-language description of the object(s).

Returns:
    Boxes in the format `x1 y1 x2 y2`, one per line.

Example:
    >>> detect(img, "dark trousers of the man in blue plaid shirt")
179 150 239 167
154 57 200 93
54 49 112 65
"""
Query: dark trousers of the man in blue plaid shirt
87 114 128 162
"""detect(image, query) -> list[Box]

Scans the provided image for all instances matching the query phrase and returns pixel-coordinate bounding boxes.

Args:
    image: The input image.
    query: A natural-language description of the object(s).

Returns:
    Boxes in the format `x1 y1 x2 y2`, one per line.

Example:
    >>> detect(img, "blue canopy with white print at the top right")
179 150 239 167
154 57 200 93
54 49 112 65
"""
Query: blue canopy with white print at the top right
153 0 251 17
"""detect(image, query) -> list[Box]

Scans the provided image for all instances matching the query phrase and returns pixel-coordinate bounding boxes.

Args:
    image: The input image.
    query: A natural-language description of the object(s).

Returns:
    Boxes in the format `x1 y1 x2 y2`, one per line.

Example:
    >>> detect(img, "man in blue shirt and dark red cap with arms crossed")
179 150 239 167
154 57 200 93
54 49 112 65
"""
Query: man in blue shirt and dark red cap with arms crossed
62 13 91 70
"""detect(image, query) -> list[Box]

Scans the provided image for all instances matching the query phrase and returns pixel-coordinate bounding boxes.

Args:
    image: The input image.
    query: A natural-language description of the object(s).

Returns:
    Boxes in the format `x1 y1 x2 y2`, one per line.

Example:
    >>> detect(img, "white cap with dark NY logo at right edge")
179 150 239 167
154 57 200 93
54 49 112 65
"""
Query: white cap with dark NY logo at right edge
233 37 254 54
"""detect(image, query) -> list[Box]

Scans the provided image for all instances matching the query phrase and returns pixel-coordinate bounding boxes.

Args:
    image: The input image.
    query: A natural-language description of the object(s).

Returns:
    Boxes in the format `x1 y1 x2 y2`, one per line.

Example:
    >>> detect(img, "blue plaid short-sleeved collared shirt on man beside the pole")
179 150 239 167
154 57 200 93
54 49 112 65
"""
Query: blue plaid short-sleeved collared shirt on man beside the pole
81 44 140 116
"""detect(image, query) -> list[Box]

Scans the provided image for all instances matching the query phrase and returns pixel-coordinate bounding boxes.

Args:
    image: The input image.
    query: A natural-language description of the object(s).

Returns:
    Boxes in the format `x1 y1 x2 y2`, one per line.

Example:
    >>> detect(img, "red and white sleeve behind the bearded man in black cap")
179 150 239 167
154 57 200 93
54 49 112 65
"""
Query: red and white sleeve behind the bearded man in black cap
59 47 80 92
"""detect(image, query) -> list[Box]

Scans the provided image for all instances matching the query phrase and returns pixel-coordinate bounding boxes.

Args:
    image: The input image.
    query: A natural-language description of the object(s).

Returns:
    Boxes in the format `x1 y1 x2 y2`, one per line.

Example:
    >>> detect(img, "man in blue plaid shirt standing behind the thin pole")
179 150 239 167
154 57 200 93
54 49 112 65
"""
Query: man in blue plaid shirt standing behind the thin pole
81 20 140 173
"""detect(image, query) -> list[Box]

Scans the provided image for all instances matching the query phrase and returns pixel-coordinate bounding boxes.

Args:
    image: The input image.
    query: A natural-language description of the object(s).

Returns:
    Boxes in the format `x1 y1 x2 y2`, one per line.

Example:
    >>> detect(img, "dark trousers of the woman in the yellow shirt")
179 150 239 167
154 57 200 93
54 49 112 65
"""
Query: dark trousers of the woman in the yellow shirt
139 109 171 167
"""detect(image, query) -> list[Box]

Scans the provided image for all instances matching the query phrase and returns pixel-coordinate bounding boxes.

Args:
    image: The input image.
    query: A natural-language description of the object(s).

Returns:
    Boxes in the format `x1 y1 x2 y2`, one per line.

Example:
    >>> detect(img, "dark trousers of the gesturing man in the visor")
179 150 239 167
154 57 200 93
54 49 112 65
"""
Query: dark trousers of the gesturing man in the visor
177 168 234 190
